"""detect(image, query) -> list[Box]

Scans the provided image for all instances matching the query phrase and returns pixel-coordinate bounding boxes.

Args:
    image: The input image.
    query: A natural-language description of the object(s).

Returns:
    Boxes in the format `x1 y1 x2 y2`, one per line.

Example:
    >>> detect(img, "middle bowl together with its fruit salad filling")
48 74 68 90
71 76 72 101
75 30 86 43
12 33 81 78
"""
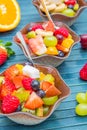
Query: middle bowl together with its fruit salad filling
14 21 80 66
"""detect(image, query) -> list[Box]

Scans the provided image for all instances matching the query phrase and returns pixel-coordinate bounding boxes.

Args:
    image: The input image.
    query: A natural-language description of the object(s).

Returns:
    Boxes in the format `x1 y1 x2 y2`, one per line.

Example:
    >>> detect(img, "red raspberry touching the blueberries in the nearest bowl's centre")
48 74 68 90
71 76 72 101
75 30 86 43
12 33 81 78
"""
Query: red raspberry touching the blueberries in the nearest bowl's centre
22 77 33 92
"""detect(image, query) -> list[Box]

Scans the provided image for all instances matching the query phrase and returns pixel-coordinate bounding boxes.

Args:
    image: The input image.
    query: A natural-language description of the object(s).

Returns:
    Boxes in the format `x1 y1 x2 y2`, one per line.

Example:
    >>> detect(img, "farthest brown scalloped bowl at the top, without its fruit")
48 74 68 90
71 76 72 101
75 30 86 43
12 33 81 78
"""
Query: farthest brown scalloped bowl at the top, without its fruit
32 0 87 26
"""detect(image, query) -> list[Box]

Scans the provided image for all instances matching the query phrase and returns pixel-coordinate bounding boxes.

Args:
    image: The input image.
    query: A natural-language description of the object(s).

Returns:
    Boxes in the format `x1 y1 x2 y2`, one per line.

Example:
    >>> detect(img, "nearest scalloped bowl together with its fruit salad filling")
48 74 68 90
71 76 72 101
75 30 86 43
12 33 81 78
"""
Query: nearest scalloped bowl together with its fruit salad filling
0 63 70 125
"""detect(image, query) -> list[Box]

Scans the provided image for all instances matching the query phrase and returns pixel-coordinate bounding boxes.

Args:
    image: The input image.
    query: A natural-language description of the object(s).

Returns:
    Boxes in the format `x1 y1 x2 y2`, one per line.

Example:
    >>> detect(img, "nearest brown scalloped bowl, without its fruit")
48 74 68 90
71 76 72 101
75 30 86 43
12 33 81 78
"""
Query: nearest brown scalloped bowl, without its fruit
0 64 70 125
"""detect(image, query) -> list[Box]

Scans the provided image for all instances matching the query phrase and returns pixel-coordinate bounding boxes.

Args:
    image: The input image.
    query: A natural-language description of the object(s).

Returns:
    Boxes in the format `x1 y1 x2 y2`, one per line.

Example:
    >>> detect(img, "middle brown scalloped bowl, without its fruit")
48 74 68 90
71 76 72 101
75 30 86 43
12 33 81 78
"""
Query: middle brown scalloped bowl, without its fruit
13 22 80 67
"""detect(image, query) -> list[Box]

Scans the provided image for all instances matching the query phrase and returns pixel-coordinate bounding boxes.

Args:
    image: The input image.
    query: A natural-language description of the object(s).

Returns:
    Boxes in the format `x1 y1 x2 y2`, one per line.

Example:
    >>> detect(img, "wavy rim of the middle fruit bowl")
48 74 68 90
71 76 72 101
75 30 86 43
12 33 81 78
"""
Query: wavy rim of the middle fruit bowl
13 20 80 60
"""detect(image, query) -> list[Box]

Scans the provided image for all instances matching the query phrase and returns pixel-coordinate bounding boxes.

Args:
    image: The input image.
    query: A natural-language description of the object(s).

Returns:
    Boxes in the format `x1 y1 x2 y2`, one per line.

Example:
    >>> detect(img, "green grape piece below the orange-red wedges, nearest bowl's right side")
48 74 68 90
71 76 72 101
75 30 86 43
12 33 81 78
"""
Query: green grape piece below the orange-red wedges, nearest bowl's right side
43 96 58 106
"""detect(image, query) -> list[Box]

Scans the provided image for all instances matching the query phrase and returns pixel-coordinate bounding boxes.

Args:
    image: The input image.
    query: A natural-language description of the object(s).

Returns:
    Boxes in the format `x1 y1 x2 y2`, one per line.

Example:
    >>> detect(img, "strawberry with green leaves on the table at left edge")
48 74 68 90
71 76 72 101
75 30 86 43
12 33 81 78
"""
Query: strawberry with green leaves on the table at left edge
0 42 14 66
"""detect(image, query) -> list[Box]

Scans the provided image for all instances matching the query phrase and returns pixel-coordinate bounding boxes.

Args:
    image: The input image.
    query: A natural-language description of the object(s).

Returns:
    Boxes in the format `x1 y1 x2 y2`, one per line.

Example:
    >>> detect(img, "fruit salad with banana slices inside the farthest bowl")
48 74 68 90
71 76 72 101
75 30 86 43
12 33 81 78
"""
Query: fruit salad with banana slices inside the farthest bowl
40 0 79 17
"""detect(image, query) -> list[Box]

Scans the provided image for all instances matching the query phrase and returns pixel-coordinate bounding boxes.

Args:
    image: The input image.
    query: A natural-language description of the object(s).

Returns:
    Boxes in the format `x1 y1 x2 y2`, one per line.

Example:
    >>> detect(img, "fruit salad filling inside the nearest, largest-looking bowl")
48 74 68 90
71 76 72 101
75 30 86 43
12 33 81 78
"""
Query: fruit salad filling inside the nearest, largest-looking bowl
0 63 61 117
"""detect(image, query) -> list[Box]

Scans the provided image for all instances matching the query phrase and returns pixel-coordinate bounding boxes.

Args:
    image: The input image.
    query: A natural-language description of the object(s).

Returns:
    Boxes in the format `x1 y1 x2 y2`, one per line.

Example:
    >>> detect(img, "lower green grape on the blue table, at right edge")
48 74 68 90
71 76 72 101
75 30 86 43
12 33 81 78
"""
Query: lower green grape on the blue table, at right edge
75 103 87 116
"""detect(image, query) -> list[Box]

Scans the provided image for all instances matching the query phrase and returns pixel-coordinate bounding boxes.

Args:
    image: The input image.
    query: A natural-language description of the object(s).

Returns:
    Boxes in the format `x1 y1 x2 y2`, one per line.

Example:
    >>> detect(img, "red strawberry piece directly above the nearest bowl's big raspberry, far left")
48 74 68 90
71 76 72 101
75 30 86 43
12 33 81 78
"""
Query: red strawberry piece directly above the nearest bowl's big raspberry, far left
1 78 16 98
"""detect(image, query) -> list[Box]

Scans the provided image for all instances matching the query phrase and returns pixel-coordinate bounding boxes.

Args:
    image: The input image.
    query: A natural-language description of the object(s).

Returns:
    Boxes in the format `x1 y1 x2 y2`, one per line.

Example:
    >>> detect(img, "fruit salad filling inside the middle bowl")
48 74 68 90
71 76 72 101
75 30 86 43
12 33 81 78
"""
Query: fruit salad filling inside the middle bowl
17 21 74 57
